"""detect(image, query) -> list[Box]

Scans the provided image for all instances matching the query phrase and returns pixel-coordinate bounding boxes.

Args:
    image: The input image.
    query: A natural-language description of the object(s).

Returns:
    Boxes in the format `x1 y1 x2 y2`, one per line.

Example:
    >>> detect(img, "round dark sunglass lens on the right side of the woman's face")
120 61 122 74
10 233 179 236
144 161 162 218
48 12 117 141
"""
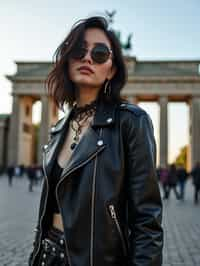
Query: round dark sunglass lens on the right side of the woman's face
91 45 110 64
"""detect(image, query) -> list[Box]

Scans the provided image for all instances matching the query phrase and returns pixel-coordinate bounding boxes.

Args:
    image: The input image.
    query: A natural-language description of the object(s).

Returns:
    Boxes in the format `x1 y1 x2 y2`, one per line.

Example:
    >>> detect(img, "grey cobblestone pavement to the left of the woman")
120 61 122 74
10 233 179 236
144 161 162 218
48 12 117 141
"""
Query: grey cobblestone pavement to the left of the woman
0 176 41 266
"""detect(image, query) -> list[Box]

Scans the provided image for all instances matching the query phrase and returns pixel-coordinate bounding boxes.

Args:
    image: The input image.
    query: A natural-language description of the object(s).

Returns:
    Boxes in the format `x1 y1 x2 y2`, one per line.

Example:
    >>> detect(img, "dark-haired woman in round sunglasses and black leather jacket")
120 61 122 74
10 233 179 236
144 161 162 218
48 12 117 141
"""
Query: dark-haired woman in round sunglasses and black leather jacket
29 17 163 266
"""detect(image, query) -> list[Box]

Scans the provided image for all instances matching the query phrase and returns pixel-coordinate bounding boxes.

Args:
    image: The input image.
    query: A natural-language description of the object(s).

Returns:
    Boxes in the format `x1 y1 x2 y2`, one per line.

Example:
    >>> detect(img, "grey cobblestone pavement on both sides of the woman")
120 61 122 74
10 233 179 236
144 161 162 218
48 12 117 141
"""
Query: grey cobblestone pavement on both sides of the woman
0 176 200 266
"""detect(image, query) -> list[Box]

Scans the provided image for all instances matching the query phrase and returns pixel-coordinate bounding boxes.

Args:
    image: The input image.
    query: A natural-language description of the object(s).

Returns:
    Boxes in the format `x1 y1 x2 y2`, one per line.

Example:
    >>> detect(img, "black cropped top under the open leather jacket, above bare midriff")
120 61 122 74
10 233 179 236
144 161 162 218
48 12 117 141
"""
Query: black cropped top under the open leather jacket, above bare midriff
51 159 63 213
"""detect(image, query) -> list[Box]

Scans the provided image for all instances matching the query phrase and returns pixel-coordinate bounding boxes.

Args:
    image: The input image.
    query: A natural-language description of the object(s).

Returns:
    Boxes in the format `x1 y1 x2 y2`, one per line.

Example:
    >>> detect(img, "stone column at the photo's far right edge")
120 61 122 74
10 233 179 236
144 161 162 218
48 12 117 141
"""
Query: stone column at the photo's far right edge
190 97 200 168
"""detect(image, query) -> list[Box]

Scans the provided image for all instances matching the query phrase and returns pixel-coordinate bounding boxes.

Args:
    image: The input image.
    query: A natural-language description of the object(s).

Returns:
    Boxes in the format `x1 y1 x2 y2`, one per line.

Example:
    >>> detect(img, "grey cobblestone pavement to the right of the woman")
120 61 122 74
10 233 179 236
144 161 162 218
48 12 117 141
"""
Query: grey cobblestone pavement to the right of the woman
163 181 200 266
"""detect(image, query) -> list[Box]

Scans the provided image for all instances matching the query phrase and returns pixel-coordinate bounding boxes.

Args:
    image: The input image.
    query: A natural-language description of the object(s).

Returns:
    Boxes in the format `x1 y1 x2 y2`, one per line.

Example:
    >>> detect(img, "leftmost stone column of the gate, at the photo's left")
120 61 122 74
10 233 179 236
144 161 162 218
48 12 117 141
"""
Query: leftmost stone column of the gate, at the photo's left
8 94 21 165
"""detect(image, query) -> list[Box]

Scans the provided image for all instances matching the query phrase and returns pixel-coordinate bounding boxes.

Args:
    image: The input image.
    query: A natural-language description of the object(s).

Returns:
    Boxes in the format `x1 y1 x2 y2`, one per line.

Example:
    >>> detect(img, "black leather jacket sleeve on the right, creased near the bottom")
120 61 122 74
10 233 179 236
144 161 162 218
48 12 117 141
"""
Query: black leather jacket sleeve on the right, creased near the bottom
126 113 163 266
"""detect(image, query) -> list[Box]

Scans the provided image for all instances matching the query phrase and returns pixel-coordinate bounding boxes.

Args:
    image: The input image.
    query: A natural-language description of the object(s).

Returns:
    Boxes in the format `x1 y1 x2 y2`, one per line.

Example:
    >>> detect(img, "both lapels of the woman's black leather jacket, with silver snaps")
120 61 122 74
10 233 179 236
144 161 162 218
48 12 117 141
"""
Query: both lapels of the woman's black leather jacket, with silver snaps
45 100 119 181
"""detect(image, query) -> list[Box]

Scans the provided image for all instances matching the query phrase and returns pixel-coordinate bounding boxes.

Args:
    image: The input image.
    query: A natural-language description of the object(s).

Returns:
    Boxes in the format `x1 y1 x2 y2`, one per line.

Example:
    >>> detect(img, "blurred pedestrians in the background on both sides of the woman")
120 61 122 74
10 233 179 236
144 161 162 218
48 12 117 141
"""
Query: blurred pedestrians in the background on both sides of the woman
1 162 200 204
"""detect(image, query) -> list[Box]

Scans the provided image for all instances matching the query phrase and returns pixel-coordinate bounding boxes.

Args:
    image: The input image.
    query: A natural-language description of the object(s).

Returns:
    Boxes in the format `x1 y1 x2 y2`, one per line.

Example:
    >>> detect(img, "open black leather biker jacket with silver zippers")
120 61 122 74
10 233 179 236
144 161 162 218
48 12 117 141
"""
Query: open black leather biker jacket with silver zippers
29 102 163 266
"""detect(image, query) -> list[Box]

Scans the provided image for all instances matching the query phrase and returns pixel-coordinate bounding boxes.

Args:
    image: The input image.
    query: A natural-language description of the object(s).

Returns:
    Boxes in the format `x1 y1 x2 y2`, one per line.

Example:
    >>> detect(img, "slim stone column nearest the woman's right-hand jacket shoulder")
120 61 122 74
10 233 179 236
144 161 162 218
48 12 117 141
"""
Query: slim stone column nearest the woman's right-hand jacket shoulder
159 96 168 167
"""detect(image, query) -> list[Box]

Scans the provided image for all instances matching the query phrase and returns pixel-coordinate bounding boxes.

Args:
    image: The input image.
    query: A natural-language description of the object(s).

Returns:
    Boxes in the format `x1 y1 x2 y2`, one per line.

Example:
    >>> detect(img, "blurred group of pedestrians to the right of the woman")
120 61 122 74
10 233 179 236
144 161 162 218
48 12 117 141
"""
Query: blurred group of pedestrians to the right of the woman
158 162 200 204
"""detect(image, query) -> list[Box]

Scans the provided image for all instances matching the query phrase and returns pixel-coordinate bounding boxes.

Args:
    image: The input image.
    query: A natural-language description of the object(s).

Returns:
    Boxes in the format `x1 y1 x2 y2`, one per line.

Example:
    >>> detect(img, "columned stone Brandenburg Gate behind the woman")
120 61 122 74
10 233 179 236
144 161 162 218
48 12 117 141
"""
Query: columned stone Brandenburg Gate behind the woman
7 56 200 168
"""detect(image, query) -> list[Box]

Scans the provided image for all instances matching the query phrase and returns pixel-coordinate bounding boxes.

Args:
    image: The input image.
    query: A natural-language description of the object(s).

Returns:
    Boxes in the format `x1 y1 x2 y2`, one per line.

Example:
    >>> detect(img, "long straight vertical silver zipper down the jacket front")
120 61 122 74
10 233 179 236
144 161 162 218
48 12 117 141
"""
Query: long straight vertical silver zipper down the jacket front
90 128 102 266
